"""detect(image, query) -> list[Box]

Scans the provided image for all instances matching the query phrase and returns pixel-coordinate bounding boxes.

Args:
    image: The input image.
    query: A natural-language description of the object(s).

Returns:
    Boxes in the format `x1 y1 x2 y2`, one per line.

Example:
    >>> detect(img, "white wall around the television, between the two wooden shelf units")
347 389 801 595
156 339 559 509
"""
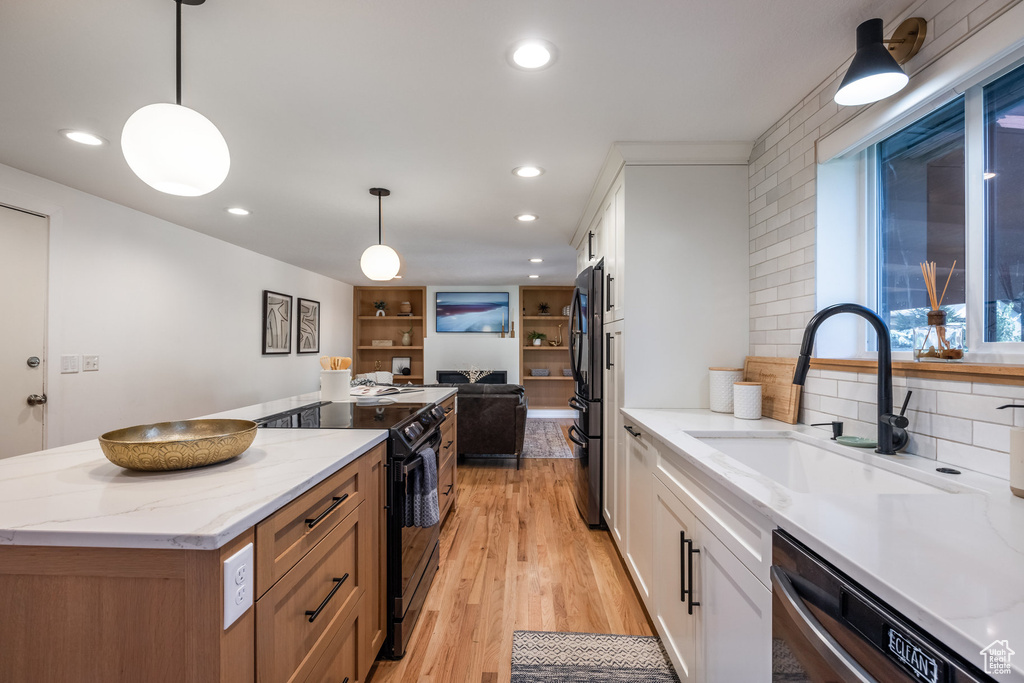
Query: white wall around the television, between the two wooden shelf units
423 285 521 384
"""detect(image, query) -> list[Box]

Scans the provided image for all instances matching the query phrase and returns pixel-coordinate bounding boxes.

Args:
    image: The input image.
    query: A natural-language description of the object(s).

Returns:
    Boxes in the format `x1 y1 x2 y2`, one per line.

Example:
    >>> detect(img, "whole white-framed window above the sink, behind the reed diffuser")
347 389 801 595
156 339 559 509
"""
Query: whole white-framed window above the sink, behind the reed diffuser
864 59 1024 362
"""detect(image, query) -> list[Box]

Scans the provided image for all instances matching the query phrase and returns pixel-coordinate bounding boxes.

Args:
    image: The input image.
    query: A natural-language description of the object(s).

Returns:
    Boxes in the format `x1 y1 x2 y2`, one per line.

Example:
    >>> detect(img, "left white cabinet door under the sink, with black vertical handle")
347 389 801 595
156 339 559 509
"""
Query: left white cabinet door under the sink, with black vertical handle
650 475 700 682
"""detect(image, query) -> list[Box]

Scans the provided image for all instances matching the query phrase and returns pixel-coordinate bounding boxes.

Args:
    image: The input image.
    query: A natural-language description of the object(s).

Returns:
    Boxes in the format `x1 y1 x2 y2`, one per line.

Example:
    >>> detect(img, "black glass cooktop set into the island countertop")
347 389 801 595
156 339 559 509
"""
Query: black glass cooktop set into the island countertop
256 401 433 429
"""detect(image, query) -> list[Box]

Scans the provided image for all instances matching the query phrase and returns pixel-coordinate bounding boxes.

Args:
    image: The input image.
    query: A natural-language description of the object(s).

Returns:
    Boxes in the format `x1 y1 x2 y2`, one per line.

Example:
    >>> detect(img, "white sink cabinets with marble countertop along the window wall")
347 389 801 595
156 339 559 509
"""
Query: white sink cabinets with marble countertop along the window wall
606 409 1024 681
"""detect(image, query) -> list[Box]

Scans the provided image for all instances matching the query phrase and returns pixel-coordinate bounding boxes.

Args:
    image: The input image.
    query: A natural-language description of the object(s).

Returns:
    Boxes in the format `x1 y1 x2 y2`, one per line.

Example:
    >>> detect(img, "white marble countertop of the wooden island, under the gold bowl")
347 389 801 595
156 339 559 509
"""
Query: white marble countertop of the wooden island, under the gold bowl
0 388 456 550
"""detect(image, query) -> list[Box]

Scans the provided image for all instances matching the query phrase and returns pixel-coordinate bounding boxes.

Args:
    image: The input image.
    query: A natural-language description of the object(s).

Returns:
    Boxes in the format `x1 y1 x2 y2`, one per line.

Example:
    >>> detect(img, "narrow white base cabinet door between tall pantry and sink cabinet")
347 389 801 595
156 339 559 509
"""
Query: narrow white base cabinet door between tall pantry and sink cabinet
625 421 655 604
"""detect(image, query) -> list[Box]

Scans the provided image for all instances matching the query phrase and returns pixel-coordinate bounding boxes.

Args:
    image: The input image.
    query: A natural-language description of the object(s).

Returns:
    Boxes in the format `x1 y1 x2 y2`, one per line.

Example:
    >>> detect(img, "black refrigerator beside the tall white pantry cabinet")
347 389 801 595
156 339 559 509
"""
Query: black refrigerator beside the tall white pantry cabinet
569 261 604 527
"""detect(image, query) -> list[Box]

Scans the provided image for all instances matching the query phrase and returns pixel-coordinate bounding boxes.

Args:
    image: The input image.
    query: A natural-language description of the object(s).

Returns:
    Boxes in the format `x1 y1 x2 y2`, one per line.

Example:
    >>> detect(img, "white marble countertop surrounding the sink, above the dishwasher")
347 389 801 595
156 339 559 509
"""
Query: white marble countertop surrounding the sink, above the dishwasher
622 409 1024 681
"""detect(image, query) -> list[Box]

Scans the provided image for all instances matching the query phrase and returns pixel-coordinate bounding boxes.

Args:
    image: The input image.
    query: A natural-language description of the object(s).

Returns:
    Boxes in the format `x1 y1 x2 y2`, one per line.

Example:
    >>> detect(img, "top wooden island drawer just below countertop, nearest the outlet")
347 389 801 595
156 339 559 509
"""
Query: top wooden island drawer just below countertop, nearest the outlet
256 444 385 597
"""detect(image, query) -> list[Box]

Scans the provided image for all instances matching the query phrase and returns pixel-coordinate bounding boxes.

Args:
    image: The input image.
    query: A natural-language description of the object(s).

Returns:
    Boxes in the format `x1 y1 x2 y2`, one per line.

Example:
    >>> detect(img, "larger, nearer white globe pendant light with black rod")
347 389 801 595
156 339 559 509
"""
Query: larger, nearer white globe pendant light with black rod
121 0 231 197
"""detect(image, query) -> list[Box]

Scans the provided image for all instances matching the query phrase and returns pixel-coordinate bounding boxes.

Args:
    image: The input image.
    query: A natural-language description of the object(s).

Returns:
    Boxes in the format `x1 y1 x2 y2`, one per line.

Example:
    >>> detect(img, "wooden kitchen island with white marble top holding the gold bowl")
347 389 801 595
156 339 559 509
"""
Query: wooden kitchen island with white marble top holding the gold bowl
0 388 455 683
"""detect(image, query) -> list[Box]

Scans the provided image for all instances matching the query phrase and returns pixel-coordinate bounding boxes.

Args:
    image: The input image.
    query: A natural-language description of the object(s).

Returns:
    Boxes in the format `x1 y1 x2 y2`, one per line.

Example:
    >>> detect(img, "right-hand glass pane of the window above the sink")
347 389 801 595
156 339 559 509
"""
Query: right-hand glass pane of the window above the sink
983 69 1024 342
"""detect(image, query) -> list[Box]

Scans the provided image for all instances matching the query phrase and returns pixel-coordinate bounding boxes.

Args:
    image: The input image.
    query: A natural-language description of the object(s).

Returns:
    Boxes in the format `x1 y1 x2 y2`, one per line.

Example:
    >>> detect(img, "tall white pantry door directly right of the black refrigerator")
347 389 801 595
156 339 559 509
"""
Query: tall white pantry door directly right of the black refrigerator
601 322 629 544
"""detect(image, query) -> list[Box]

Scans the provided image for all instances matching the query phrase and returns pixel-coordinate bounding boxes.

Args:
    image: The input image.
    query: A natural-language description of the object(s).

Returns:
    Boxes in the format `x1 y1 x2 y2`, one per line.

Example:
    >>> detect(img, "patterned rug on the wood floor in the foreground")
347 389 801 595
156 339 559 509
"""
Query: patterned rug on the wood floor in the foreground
512 631 679 683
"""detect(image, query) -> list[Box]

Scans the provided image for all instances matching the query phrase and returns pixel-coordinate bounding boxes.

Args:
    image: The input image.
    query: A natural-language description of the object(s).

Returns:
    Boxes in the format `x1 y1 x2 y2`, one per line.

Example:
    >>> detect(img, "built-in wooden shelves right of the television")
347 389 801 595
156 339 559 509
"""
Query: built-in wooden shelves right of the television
518 286 573 409
